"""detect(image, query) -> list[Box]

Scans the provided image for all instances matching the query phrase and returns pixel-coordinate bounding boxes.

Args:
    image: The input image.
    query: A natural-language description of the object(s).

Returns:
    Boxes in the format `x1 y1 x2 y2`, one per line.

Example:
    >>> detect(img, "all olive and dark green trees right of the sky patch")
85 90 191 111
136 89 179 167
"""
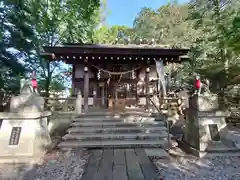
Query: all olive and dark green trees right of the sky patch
128 0 240 89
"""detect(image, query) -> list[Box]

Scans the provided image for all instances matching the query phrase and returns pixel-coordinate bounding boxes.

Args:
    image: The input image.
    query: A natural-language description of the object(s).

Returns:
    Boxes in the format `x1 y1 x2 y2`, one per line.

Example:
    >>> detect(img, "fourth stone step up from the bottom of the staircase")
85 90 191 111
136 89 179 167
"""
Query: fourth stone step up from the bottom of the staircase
71 121 165 127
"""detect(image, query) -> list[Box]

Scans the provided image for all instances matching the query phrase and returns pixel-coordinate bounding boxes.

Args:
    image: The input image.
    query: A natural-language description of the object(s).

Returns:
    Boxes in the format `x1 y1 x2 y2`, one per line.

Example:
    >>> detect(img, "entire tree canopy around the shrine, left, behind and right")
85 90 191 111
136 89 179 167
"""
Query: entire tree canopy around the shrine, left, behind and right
0 0 240 96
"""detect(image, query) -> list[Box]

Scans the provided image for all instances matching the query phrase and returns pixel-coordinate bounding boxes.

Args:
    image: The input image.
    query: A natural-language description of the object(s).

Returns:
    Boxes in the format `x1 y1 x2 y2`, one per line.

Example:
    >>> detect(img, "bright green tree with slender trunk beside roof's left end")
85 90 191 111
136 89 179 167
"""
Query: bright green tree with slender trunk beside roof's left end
32 0 99 96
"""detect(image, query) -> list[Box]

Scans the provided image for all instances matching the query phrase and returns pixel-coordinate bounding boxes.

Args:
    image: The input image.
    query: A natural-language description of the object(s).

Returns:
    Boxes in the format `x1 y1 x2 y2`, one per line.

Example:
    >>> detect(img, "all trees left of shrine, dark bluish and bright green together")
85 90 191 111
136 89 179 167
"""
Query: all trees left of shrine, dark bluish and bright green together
0 0 100 96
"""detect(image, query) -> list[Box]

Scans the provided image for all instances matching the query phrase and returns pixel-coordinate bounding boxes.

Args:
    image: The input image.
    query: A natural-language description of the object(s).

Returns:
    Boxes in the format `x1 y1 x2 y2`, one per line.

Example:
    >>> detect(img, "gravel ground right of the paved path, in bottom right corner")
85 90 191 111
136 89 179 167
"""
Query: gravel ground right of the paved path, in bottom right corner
153 156 240 180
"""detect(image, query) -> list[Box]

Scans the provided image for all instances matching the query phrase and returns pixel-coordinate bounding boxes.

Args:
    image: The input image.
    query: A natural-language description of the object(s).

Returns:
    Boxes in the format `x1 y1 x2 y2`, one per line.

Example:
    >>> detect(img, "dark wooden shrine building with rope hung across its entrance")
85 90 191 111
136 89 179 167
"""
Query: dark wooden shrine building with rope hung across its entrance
42 44 189 109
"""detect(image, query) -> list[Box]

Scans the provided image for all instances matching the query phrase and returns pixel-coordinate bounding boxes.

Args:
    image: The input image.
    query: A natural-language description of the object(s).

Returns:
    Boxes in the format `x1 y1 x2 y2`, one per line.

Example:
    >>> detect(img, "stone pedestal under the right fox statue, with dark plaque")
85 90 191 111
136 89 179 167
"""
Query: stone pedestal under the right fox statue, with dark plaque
184 94 234 156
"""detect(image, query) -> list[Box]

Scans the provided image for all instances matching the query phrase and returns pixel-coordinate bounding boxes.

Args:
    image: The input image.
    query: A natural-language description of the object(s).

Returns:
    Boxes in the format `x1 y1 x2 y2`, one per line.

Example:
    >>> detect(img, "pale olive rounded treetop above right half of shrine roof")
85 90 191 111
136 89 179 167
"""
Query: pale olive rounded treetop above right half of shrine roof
133 3 198 47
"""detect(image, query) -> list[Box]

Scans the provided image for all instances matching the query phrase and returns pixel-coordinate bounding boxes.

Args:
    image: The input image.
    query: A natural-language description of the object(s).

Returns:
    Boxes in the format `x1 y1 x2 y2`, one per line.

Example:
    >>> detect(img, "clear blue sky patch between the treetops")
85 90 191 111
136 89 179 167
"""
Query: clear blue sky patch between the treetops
107 0 188 27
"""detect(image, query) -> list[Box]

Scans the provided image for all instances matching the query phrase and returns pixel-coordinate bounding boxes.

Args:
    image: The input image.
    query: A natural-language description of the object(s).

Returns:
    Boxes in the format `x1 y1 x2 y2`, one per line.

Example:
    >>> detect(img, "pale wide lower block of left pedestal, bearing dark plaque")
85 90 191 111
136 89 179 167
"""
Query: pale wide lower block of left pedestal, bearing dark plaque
0 112 51 162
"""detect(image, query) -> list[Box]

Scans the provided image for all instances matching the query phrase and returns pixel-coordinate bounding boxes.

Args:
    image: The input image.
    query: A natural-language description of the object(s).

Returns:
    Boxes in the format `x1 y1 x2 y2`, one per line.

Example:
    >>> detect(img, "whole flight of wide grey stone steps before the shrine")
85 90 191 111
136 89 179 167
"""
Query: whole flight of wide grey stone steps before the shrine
58 112 167 149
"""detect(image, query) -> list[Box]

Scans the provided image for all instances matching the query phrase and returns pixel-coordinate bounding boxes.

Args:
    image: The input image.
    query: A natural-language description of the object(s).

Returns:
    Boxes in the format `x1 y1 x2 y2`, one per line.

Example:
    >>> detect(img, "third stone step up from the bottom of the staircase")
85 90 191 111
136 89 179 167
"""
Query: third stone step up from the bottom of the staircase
67 126 166 133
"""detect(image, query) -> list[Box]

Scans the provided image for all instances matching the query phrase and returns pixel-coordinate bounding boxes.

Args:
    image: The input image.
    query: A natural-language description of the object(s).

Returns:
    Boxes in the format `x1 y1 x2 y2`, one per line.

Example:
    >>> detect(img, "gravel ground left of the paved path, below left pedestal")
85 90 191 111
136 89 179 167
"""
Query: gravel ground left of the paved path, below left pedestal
0 150 89 180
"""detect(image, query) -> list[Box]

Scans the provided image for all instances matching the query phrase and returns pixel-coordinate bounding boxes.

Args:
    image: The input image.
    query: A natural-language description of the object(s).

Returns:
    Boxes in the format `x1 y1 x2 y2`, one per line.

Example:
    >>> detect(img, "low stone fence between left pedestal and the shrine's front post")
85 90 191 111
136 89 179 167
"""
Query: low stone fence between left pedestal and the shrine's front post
44 97 76 112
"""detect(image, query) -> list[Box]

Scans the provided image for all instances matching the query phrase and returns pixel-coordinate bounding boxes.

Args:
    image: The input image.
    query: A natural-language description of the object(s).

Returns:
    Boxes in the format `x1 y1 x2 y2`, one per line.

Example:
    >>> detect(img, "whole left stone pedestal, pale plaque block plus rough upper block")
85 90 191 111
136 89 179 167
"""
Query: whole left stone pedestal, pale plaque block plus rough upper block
0 93 51 163
